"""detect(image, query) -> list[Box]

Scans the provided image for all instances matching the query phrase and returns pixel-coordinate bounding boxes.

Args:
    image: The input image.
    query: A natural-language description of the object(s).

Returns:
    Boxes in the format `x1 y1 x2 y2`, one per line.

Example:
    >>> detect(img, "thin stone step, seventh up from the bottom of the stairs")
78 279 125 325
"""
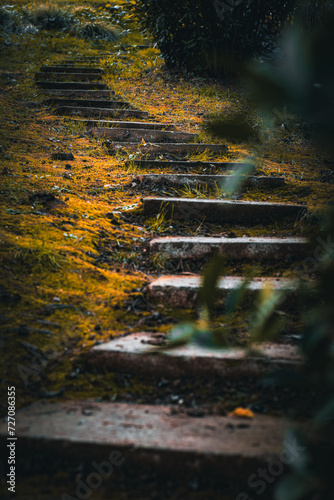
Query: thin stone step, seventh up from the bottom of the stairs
125 158 245 170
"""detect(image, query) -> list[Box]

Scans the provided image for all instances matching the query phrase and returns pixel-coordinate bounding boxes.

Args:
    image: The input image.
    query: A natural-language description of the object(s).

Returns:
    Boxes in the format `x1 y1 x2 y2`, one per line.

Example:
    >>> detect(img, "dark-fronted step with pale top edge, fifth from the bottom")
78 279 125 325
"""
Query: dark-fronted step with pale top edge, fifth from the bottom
144 197 306 225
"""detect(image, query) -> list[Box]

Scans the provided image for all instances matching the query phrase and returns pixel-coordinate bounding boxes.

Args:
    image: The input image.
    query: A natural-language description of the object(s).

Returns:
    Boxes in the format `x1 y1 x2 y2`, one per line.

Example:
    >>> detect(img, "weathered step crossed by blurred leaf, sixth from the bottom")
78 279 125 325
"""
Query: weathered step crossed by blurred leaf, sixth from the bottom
136 174 285 190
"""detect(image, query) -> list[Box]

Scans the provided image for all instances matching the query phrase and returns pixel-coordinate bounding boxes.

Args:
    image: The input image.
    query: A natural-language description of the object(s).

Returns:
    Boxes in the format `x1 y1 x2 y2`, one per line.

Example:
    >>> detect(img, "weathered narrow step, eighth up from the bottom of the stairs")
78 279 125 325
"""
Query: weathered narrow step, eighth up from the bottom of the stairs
114 142 228 156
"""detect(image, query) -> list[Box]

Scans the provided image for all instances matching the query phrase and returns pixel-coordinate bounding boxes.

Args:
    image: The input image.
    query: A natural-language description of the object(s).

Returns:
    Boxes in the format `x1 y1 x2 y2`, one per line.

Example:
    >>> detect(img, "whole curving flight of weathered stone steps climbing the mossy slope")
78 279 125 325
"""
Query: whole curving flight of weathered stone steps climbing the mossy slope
0 52 307 500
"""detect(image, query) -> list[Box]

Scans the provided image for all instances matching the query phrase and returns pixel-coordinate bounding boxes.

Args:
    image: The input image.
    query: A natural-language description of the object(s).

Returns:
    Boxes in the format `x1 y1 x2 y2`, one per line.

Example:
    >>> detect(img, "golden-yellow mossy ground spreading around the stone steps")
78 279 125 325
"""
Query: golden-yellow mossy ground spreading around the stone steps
0 0 333 418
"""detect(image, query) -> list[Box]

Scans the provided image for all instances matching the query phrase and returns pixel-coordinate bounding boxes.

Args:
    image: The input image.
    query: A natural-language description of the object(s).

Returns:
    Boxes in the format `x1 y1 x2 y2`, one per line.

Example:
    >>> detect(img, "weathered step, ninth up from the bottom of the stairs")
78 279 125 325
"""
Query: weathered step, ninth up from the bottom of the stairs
91 127 197 143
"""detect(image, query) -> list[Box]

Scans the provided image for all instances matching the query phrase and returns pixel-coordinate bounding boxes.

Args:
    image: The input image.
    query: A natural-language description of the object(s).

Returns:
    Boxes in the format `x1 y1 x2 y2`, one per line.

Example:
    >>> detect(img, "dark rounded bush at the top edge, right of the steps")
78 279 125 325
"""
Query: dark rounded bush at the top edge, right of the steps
128 0 294 74
